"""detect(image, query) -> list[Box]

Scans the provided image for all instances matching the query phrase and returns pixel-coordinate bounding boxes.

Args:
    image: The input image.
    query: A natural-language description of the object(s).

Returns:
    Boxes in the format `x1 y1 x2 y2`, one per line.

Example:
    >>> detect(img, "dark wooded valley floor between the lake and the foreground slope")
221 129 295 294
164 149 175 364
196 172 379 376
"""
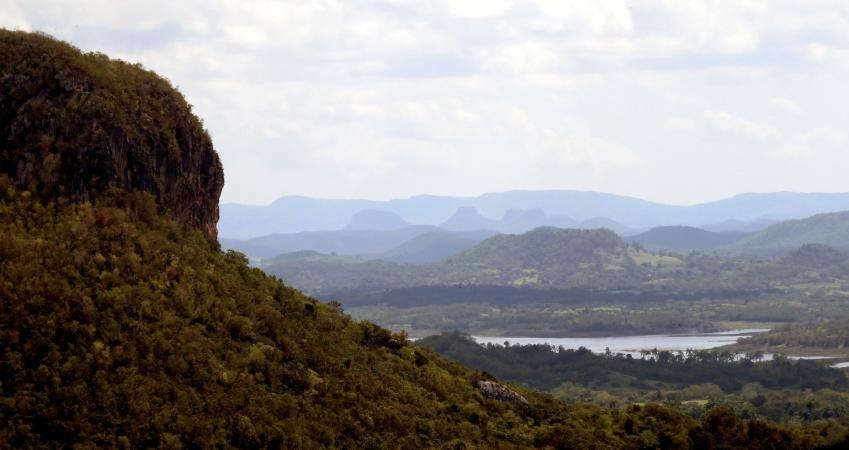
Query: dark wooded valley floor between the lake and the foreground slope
416 333 849 425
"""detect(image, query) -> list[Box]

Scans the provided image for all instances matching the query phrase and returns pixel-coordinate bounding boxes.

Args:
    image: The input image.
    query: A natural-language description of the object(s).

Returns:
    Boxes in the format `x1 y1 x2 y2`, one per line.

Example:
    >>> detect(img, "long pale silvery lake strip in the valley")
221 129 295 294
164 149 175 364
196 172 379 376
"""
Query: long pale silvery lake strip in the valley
472 328 769 357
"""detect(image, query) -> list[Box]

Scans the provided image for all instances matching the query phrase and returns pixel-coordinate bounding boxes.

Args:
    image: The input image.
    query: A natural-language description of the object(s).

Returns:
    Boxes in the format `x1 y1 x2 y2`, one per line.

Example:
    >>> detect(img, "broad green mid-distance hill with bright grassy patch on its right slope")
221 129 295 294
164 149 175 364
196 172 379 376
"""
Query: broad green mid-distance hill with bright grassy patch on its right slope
263 227 682 295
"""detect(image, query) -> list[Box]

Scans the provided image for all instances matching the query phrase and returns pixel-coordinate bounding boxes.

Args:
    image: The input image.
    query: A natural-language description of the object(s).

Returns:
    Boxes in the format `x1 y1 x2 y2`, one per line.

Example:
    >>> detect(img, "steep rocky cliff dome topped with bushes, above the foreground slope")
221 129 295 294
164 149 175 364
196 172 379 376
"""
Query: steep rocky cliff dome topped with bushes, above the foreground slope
0 30 224 239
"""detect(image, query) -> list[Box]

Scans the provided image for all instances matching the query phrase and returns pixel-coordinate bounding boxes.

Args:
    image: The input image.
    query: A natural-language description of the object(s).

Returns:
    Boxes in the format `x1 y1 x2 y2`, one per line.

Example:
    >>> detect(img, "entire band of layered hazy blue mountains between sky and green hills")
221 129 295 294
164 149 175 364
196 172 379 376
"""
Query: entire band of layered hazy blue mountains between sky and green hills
220 191 849 264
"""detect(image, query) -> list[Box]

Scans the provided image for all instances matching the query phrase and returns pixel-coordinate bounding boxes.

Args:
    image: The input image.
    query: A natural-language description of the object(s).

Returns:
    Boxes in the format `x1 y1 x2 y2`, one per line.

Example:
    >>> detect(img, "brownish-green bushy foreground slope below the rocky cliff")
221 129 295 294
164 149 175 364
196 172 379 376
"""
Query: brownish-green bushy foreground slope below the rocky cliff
0 179 604 448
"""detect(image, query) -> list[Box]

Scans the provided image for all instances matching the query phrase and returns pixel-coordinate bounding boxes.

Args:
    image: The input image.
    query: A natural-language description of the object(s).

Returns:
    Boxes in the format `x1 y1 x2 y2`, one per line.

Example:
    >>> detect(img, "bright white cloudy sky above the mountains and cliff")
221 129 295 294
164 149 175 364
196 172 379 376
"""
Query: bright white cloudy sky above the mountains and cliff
0 0 849 204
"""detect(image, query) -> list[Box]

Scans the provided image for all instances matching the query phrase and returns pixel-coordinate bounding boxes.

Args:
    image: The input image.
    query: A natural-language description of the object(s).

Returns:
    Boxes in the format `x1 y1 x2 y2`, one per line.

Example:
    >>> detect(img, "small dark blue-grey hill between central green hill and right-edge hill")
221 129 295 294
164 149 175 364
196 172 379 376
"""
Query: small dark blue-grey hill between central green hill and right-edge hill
628 226 748 253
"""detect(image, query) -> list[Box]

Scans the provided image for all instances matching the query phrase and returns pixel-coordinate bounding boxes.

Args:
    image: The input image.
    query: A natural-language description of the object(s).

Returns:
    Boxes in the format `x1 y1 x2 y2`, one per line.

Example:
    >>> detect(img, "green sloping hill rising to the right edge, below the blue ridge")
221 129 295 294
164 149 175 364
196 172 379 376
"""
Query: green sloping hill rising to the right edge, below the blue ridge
726 212 849 255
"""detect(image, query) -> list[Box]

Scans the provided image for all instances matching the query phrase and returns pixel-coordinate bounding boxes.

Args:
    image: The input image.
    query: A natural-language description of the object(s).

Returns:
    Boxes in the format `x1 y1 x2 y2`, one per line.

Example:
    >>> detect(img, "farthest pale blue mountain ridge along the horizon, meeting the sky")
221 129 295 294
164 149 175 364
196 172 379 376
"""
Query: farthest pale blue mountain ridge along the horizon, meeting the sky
218 191 849 239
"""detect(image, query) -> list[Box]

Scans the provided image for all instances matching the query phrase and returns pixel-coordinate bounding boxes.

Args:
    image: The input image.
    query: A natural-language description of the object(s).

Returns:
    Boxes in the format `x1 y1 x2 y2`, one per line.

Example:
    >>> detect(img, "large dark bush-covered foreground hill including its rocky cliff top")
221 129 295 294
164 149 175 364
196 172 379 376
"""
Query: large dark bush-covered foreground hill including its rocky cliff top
0 31 846 449
